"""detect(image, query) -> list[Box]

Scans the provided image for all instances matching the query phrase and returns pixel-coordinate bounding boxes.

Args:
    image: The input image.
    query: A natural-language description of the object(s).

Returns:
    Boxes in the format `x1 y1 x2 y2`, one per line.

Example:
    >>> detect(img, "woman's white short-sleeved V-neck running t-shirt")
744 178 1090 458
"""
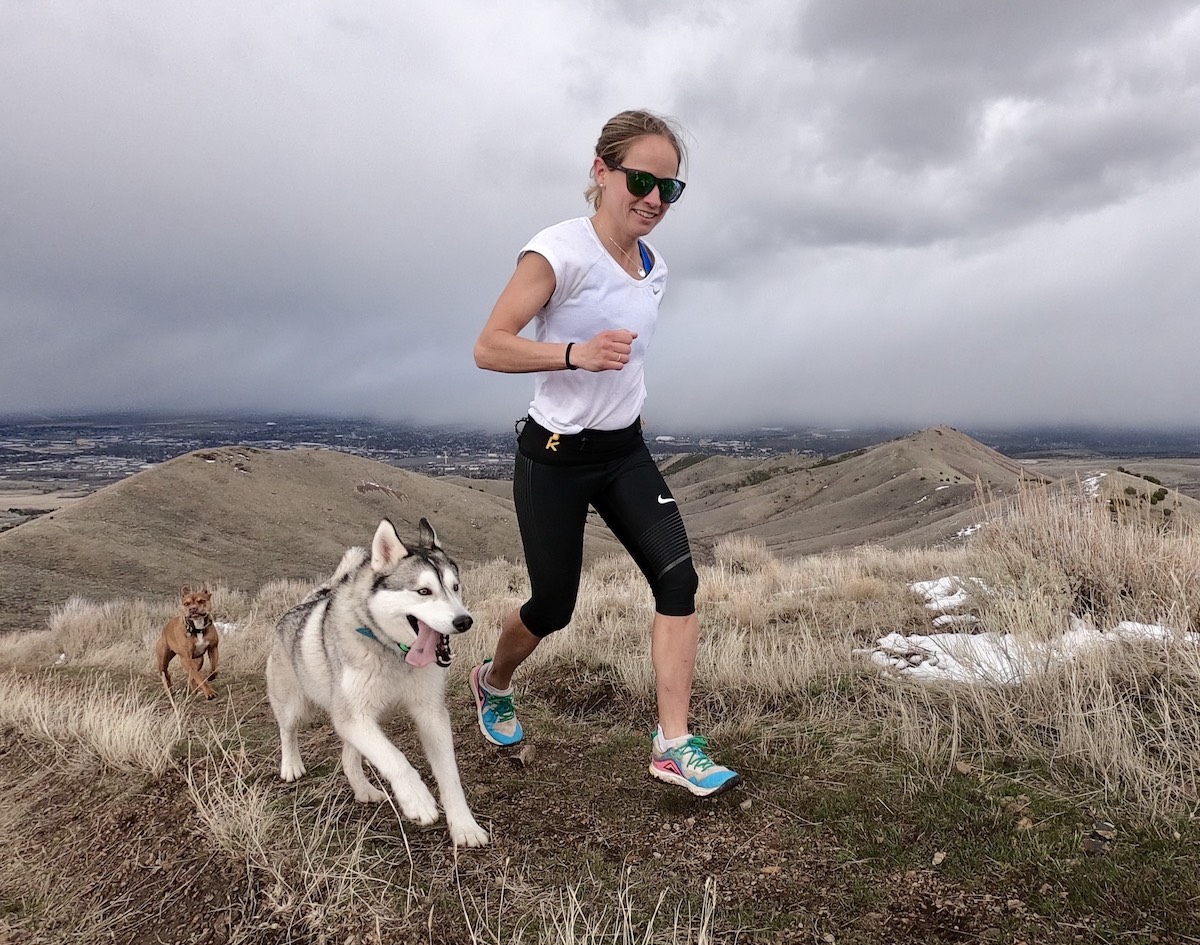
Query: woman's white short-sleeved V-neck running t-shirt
518 217 667 434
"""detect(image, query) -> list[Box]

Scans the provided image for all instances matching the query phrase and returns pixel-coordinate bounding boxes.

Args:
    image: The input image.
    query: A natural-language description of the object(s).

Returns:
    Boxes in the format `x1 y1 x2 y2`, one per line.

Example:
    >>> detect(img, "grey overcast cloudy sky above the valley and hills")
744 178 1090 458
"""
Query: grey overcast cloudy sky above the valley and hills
0 0 1200 429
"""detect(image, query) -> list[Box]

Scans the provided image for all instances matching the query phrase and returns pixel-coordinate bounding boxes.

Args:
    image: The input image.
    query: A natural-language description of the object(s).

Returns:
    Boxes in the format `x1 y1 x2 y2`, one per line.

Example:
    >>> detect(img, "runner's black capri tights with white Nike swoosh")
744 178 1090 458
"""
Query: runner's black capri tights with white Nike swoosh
512 443 700 637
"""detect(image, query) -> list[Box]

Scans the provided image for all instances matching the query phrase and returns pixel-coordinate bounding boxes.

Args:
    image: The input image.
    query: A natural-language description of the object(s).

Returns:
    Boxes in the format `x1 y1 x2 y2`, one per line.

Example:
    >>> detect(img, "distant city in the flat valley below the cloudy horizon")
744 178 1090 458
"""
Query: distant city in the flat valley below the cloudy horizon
0 415 1200 489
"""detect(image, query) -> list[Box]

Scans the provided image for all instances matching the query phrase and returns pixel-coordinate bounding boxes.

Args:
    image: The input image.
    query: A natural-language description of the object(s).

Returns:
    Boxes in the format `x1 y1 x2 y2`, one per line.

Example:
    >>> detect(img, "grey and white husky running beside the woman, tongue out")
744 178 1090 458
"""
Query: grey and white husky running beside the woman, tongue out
266 518 487 847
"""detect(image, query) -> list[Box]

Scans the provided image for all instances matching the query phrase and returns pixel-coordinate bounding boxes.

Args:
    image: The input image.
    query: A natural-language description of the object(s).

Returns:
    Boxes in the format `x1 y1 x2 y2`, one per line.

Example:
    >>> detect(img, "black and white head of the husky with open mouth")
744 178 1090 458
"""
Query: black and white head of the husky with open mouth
370 518 473 639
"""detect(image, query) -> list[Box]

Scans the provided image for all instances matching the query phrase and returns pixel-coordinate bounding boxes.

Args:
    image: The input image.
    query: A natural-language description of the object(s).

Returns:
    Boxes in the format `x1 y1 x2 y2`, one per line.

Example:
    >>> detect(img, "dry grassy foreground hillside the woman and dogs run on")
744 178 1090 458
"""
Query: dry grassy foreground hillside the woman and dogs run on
0 489 1200 945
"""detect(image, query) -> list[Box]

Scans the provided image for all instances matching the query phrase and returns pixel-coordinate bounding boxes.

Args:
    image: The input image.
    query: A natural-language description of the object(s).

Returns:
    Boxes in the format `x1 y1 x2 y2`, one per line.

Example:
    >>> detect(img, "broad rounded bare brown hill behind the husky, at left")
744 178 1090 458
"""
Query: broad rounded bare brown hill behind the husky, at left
0 446 617 631
